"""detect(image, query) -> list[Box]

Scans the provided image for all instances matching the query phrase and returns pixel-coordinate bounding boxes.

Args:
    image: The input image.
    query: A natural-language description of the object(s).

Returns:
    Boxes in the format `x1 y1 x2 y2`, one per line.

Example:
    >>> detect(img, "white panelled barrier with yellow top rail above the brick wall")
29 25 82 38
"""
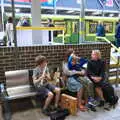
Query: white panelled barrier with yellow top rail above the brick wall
16 27 65 46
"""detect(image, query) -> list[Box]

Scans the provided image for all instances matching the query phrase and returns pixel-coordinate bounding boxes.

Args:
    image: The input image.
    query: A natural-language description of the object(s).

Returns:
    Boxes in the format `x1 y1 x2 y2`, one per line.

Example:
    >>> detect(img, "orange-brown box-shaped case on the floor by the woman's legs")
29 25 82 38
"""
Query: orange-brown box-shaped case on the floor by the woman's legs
61 94 77 115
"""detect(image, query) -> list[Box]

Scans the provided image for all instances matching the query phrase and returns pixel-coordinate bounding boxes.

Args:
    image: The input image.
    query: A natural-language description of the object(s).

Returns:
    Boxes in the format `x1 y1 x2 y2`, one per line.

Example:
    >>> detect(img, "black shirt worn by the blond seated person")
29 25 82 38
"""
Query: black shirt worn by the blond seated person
87 59 105 82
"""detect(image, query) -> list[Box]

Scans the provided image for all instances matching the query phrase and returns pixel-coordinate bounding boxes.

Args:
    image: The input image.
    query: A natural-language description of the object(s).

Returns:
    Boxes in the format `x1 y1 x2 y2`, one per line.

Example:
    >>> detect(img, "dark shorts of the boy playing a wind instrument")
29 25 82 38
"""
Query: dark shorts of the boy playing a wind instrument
36 83 56 98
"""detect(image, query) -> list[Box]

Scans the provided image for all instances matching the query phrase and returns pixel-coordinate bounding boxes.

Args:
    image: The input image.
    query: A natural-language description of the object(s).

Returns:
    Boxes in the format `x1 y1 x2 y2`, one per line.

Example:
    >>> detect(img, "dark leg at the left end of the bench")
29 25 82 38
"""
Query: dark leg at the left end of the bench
3 100 12 120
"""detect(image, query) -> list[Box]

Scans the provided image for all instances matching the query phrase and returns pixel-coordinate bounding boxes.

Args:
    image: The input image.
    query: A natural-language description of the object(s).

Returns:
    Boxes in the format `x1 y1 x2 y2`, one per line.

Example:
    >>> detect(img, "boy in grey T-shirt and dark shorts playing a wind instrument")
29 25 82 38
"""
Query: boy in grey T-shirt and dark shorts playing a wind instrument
33 55 60 115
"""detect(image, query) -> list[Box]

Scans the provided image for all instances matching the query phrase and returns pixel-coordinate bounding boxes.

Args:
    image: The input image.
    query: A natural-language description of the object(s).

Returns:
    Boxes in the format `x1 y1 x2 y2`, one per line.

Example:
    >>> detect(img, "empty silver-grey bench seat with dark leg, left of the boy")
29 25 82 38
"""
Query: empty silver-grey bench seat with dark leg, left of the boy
2 69 37 120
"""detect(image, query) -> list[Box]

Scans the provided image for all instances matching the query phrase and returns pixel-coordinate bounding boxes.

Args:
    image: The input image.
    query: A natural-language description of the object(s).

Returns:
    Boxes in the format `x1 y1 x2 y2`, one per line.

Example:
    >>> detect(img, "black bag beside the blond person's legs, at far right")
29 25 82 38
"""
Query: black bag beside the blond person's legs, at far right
102 82 119 105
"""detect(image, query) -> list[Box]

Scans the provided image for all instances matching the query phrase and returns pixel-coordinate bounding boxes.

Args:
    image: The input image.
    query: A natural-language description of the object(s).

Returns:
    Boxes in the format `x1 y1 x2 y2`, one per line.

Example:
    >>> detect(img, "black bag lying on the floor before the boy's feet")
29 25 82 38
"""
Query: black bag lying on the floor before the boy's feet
50 109 69 120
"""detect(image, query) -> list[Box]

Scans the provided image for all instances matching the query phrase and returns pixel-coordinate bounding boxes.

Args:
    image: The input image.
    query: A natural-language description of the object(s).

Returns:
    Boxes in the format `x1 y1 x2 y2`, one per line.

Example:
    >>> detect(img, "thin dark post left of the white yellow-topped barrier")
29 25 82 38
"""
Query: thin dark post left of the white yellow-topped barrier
11 0 17 47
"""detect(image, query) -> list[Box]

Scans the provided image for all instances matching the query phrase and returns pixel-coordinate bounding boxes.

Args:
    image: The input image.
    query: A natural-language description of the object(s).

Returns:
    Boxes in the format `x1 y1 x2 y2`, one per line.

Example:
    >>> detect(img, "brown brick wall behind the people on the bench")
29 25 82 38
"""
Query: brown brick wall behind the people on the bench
0 43 110 82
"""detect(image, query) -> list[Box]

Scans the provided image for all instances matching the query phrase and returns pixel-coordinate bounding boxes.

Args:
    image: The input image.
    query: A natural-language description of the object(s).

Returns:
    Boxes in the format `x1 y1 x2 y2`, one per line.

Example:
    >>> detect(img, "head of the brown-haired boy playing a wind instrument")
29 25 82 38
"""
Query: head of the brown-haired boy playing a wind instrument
35 55 47 68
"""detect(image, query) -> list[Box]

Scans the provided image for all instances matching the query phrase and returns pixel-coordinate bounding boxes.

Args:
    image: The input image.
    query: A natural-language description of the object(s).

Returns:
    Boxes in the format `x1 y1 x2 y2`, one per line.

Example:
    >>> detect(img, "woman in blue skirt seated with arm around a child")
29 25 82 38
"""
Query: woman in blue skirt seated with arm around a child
63 49 87 111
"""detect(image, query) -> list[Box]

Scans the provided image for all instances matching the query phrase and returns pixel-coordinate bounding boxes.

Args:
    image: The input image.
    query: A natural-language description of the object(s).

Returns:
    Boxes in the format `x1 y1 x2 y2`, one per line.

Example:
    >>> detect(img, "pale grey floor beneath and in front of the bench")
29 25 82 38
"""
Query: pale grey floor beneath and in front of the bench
0 88 120 120
